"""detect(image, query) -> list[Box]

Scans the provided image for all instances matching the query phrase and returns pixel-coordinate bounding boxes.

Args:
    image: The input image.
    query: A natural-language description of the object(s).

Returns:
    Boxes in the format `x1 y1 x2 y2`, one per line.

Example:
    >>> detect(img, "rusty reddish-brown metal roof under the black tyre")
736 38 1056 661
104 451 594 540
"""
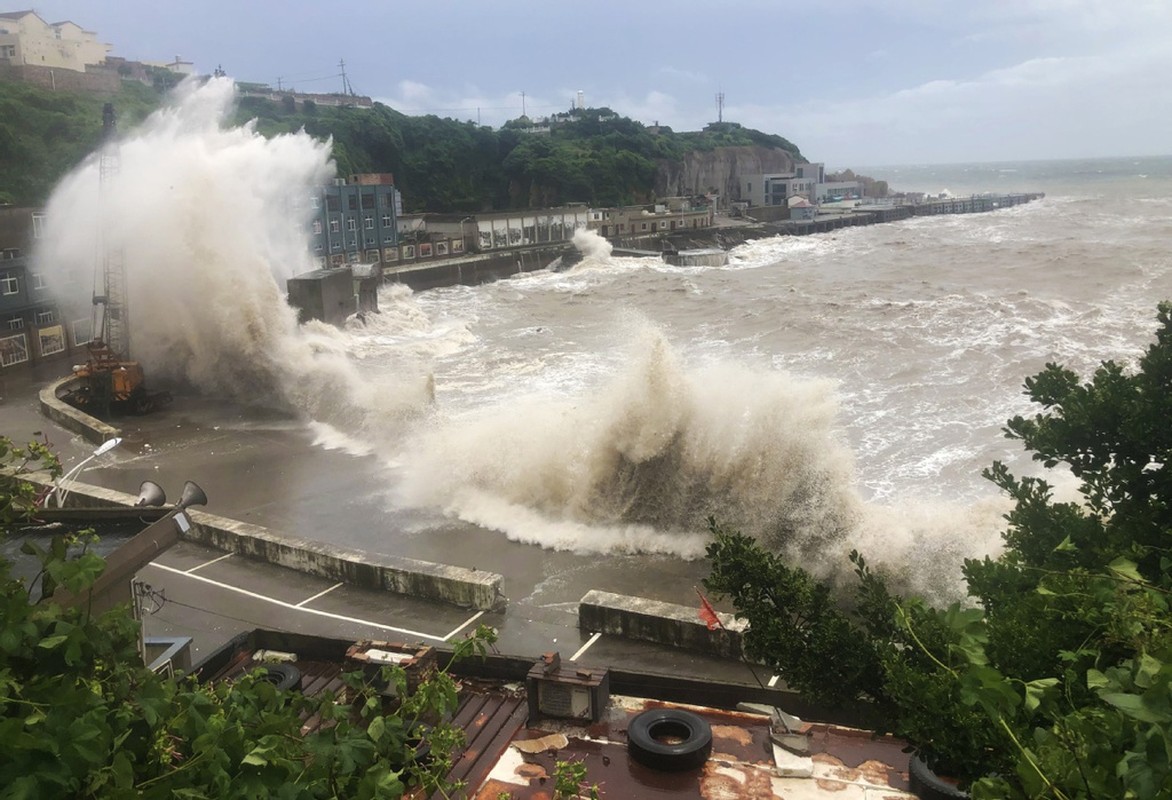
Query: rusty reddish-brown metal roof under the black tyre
201 637 913 800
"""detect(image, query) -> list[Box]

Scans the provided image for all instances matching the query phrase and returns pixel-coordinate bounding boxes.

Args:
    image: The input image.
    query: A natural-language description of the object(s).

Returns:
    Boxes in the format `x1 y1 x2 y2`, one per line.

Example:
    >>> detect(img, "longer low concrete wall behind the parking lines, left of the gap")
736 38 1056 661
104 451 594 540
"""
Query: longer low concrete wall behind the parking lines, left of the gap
27 476 506 610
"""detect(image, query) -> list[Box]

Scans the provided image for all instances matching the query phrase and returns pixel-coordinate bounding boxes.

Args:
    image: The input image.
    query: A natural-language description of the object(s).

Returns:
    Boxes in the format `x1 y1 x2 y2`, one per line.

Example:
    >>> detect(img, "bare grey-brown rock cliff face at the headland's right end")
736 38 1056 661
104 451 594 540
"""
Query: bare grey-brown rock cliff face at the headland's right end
655 146 793 205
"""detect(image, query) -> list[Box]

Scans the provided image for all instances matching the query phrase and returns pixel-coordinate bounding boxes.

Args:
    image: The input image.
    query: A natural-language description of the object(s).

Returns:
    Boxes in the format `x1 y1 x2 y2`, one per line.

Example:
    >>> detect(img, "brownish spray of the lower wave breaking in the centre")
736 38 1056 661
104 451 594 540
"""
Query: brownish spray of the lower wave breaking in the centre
400 324 860 569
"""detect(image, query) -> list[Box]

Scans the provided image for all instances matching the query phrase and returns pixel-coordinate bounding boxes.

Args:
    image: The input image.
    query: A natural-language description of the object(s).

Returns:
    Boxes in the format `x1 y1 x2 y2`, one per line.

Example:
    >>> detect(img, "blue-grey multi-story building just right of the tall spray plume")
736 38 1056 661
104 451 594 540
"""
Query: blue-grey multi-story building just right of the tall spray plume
309 172 403 268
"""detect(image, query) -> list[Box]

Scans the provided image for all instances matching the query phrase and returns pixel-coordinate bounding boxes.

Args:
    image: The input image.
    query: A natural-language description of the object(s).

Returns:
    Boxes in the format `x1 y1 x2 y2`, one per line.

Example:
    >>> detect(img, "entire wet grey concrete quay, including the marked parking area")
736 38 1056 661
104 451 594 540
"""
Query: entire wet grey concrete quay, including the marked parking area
0 367 768 685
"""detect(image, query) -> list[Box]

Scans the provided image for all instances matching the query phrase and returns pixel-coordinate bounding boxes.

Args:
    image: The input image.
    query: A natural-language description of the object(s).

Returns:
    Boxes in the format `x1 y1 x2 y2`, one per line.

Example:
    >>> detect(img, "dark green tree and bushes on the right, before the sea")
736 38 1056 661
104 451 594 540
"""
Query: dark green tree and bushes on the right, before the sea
706 302 1172 799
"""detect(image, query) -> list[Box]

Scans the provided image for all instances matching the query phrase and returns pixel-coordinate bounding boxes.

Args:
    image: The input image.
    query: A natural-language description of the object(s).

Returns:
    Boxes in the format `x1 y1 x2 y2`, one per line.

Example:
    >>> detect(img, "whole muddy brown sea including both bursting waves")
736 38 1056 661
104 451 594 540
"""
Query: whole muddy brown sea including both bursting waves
34 81 1172 600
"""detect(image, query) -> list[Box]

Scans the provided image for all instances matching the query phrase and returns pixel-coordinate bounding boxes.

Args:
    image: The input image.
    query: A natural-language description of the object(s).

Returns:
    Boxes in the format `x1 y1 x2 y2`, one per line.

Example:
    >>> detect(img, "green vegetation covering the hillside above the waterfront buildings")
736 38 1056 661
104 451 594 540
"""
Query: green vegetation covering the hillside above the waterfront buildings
0 82 805 213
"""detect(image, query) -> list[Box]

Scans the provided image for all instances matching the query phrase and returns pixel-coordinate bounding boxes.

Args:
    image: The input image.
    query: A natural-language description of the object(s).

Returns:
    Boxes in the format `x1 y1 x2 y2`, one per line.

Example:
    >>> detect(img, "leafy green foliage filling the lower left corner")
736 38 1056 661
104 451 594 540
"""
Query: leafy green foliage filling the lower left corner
0 437 495 800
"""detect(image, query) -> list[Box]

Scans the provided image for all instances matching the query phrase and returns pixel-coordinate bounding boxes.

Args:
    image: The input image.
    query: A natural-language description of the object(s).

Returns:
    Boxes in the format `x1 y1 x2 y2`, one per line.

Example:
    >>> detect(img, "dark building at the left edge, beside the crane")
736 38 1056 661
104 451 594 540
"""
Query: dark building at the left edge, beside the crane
0 206 77 369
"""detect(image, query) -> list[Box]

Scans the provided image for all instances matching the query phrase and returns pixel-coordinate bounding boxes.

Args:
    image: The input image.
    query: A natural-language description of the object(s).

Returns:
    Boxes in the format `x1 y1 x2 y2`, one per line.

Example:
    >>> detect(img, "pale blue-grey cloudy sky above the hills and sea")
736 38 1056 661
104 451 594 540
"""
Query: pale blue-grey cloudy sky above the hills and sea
18 0 1172 169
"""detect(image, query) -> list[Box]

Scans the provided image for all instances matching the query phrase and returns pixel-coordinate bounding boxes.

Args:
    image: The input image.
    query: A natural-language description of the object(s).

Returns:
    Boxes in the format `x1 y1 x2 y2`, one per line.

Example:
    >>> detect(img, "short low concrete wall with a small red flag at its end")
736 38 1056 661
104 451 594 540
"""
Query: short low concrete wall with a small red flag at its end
578 589 748 658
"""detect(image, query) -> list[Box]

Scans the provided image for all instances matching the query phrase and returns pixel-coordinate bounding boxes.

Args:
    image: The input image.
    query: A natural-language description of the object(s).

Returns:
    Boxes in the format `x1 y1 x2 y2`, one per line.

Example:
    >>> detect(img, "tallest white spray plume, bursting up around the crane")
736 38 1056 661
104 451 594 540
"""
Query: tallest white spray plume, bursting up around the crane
34 78 427 432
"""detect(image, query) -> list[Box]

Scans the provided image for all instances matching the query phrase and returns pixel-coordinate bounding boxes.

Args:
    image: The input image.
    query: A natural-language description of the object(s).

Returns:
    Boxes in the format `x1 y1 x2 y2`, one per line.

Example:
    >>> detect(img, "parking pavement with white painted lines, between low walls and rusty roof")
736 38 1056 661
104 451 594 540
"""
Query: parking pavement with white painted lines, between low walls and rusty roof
138 542 769 685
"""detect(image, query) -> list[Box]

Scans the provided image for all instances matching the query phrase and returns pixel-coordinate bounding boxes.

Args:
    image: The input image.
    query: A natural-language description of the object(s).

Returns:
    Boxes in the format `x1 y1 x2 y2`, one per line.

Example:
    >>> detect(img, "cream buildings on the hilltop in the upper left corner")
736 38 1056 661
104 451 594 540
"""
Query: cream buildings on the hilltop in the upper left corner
0 11 110 73
